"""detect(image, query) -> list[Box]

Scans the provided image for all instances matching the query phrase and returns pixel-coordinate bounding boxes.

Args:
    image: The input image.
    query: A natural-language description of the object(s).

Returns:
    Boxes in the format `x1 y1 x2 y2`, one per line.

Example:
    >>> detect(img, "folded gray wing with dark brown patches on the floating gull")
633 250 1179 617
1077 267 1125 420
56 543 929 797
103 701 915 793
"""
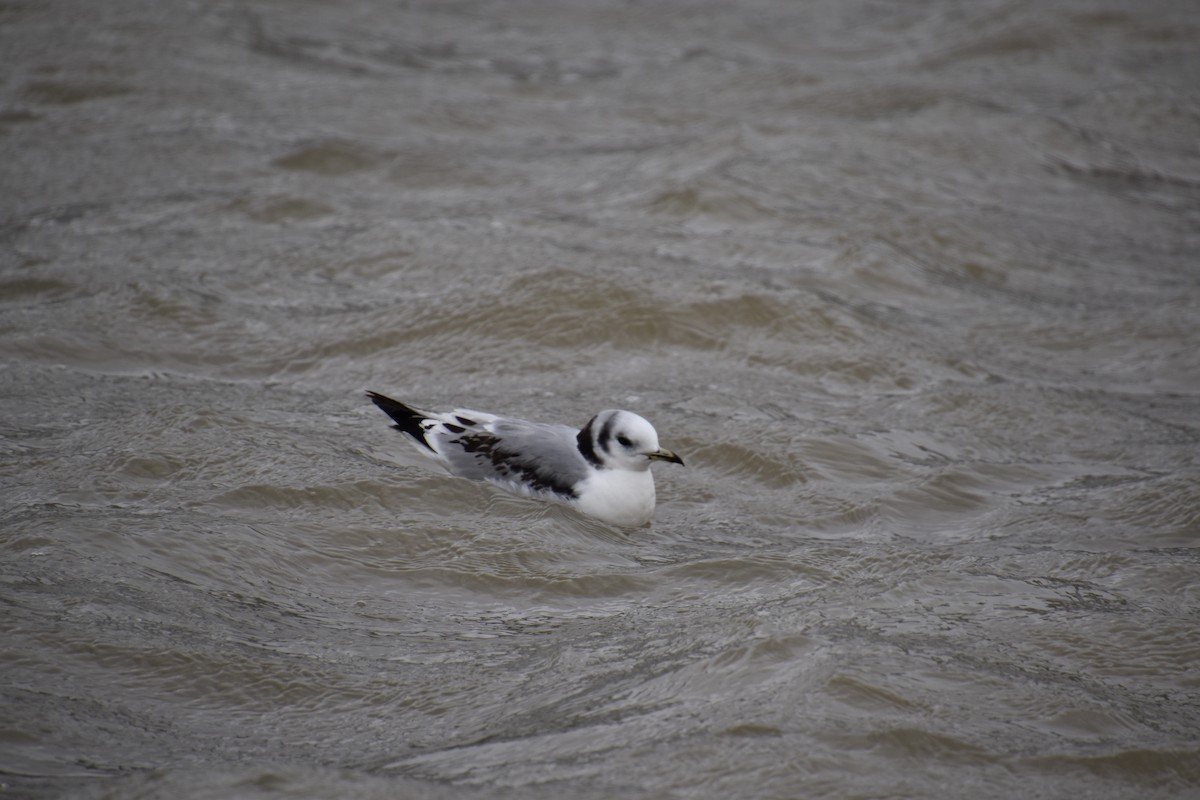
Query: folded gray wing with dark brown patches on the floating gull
438 417 589 499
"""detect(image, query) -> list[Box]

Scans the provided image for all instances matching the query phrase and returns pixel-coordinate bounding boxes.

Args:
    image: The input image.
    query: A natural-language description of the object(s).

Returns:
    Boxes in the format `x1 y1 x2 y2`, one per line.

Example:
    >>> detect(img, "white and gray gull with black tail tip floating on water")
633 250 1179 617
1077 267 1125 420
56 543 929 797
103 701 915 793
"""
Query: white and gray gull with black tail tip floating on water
367 391 683 528
